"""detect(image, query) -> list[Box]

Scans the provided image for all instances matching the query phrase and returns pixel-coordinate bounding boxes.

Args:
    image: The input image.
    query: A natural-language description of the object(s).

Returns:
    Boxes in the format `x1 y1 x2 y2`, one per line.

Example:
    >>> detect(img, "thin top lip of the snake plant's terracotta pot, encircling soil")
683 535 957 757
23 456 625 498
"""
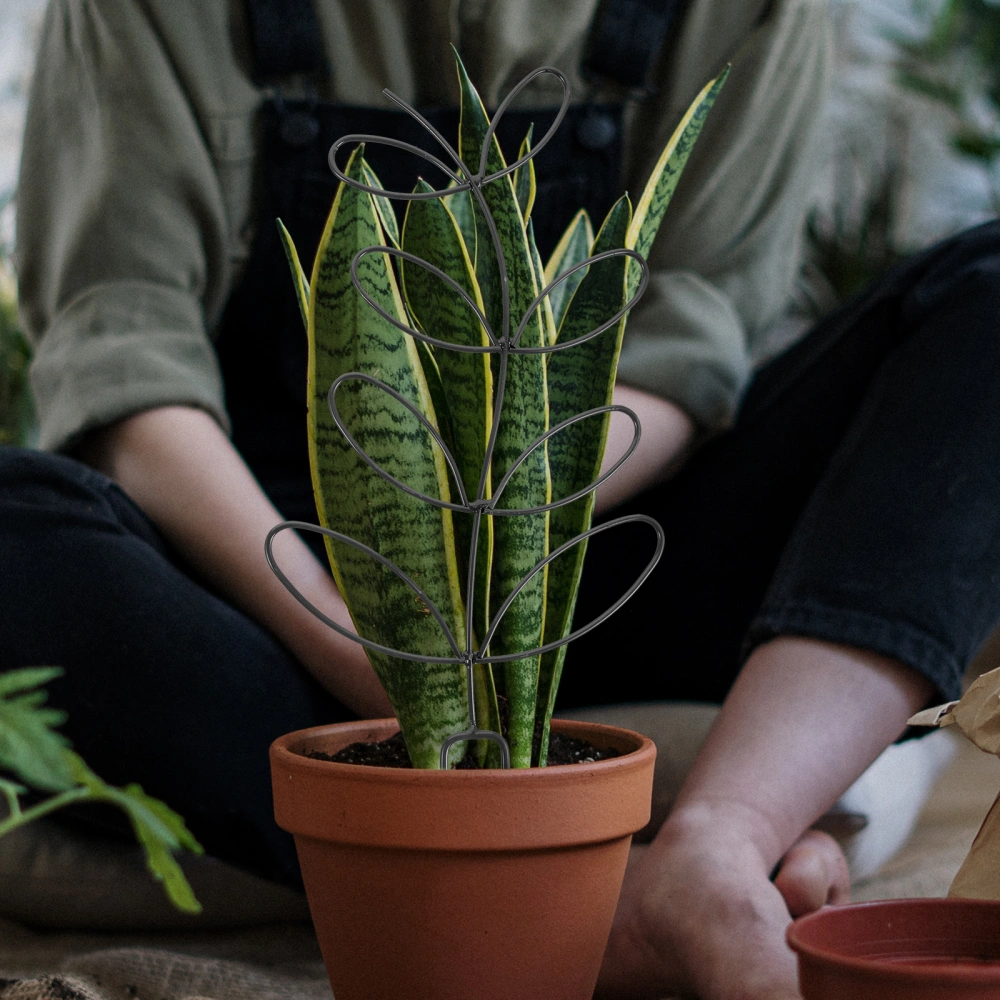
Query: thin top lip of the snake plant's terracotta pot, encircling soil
271 717 656 785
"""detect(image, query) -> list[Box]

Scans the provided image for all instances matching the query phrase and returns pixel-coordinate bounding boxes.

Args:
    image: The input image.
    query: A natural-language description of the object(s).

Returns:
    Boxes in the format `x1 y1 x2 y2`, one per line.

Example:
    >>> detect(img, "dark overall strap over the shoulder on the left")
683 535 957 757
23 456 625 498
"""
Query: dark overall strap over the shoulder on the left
246 0 328 84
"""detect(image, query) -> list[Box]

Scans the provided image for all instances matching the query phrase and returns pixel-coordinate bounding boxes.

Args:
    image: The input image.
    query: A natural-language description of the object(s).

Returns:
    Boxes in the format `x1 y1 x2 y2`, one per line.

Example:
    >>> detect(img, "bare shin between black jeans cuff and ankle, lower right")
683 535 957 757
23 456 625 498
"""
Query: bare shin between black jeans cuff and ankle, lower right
663 637 933 869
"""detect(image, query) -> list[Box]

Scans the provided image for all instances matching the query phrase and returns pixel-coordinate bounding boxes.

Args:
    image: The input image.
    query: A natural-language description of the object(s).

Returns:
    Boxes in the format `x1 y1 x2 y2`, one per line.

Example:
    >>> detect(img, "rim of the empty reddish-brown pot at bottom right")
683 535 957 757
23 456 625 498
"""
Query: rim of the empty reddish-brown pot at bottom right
785 897 1000 986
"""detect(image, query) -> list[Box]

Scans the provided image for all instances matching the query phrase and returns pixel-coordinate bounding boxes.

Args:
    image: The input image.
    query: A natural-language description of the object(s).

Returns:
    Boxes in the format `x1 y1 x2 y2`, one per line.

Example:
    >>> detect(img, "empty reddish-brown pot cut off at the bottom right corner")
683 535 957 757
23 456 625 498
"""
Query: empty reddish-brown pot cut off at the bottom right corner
788 899 1000 1000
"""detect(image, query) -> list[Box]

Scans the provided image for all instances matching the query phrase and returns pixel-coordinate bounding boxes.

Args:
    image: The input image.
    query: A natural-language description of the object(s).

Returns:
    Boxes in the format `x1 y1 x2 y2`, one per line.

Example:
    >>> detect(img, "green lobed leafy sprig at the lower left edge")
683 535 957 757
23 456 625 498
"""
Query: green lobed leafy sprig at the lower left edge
0 667 202 913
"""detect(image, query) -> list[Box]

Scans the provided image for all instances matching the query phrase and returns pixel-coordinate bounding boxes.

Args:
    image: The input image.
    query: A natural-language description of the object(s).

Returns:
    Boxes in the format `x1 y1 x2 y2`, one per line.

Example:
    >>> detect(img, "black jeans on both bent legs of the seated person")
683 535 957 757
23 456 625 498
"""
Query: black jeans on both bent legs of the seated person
0 223 1000 881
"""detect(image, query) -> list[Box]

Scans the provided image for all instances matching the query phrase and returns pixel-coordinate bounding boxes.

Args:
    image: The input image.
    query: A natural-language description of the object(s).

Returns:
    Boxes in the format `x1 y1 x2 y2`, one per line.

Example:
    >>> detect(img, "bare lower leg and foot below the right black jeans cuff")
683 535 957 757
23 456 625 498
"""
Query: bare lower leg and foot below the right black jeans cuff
595 636 933 1000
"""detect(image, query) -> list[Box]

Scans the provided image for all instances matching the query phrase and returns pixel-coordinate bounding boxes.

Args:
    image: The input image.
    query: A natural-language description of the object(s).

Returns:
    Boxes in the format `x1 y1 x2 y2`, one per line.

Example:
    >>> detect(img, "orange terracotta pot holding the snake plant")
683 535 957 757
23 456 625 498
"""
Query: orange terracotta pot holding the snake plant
271 719 656 1000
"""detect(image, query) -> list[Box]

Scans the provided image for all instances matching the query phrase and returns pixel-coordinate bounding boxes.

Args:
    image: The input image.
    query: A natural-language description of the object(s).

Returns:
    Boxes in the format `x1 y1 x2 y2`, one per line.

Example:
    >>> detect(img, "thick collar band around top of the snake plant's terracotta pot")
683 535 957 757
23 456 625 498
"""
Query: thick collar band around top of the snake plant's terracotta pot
271 719 656 851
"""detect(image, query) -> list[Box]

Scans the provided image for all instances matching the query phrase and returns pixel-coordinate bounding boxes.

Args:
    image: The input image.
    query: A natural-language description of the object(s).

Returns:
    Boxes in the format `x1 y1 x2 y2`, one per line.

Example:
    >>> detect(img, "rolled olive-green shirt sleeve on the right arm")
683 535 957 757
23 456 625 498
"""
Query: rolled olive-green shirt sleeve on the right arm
618 0 830 433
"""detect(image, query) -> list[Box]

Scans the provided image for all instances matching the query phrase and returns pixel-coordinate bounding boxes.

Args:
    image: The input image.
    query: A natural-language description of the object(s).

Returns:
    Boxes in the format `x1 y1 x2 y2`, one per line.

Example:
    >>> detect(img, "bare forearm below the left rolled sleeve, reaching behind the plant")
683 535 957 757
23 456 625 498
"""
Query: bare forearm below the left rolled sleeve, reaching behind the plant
81 406 391 715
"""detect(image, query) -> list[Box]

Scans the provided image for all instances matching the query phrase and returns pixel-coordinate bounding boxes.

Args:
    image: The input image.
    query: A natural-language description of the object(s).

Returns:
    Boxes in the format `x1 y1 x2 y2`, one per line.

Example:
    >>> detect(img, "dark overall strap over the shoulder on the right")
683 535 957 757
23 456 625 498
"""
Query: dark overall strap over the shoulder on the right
581 0 687 94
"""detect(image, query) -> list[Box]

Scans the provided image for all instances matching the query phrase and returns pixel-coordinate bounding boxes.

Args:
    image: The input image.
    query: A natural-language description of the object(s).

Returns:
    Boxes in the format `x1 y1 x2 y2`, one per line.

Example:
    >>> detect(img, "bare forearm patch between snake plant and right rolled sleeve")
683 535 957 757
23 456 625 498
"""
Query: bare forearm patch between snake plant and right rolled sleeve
596 384 694 514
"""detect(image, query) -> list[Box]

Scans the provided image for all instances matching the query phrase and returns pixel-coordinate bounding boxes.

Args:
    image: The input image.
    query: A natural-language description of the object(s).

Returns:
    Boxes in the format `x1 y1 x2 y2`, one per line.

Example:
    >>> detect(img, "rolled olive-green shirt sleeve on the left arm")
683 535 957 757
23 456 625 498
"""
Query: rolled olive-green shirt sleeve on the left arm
17 0 241 450
